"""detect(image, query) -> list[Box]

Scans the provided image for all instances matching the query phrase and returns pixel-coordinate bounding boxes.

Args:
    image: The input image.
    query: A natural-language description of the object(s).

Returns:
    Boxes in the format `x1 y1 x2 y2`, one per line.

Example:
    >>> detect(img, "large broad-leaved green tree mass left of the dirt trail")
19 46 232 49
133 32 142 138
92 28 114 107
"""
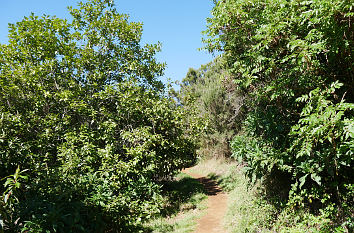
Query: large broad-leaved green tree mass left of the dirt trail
0 0 198 232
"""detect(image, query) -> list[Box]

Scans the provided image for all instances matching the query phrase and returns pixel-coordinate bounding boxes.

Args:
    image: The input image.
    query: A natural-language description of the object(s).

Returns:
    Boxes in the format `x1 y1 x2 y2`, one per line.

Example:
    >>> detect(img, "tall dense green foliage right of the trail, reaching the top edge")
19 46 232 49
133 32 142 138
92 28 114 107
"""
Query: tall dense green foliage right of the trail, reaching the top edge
204 0 354 230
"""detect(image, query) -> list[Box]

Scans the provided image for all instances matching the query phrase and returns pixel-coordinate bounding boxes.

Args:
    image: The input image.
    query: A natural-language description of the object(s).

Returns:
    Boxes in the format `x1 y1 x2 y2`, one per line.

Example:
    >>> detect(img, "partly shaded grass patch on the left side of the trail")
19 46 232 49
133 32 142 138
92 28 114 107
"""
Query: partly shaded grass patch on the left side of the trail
144 173 207 233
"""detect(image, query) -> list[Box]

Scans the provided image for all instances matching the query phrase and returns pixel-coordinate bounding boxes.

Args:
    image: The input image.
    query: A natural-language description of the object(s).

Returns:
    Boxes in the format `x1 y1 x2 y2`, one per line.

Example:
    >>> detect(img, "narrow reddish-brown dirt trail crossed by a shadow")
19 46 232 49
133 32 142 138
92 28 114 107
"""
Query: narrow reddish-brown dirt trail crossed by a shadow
183 168 228 233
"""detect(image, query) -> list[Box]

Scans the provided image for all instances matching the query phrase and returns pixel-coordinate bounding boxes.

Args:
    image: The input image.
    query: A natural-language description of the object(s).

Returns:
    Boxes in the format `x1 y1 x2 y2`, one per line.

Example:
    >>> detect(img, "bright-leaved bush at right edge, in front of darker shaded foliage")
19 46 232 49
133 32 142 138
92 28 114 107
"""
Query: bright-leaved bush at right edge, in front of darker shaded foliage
289 82 354 206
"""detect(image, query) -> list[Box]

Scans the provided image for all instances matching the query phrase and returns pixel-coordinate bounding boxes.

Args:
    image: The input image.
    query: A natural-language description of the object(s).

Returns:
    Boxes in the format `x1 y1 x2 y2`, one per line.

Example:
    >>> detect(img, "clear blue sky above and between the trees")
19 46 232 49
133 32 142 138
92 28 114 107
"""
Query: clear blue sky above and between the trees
0 0 213 86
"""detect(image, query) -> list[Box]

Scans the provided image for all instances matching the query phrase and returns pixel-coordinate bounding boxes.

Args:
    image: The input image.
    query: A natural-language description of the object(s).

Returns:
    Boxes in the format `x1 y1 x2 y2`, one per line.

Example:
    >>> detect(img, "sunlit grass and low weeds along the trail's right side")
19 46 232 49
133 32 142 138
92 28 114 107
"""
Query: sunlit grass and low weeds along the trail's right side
187 158 347 233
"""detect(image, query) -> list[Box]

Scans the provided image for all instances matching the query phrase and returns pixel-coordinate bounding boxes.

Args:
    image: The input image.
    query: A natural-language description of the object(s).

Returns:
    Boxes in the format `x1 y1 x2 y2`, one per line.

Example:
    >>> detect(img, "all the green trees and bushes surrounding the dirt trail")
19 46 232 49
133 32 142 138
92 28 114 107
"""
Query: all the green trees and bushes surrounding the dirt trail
0 0 354 232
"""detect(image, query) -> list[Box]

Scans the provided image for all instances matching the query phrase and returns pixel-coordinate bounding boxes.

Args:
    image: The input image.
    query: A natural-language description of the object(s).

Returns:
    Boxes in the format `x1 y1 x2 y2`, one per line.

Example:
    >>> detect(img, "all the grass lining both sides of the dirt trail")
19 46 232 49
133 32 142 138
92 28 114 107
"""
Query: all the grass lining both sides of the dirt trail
144 158 342 233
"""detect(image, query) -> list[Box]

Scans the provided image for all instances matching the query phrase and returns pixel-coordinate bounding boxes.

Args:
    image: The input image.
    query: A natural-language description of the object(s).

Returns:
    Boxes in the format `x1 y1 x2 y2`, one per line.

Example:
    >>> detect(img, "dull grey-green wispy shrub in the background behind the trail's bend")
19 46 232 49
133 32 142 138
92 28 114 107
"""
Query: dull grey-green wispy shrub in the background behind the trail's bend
177 57 243 157
